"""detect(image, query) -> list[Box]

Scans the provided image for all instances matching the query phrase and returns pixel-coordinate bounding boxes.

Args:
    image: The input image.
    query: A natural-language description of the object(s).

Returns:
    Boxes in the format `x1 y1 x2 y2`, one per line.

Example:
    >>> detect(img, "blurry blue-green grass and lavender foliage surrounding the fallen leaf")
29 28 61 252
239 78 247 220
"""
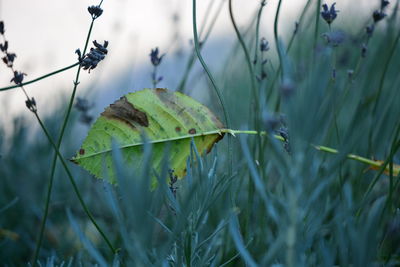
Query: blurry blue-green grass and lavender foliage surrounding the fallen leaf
0 0 400 266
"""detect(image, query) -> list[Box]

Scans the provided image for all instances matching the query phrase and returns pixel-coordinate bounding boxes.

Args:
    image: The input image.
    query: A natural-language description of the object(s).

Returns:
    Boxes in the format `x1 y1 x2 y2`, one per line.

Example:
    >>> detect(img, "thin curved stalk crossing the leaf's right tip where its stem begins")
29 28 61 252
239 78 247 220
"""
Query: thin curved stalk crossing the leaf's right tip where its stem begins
193 0 233 176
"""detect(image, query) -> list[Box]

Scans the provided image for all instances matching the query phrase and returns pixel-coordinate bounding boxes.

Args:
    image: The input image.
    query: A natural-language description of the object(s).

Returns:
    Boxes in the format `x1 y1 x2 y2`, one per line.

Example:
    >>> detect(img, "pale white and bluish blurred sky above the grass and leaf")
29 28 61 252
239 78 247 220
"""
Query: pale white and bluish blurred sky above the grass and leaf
0 0 377 127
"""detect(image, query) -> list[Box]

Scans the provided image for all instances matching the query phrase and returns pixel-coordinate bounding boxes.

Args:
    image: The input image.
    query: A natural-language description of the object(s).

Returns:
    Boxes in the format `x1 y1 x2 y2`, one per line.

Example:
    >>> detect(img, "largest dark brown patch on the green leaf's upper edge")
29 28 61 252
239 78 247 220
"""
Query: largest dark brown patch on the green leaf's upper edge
101 96 149 128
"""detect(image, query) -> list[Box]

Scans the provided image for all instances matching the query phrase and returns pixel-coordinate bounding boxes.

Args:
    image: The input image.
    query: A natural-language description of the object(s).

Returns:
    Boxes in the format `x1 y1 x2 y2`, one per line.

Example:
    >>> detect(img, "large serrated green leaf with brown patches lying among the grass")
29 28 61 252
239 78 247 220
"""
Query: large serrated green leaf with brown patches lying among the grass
72 88 224 186
